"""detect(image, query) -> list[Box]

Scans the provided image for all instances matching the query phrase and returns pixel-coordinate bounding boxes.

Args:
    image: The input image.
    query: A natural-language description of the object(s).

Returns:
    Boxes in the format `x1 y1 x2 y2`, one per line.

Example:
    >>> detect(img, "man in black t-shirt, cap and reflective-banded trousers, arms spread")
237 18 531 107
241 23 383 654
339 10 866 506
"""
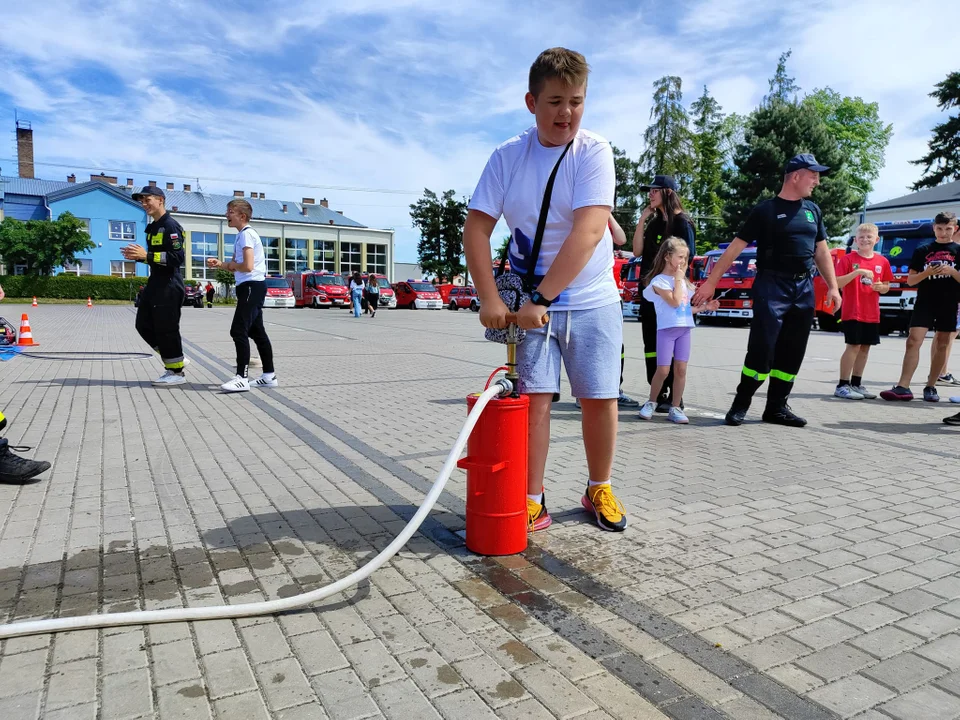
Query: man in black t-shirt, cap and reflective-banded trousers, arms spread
692 155 840 427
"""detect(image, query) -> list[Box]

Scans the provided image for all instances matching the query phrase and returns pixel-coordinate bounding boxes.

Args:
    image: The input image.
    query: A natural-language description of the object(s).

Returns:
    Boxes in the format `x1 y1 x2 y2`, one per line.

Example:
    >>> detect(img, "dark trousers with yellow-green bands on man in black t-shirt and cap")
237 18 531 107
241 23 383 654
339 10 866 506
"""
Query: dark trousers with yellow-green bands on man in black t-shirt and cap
733 271 814 410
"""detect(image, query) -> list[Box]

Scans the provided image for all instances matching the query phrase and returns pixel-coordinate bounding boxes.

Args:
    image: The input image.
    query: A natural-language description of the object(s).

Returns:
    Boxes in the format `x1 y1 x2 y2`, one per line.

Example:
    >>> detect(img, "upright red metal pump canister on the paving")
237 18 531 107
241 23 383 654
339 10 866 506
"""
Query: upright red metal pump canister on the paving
457 393 530 555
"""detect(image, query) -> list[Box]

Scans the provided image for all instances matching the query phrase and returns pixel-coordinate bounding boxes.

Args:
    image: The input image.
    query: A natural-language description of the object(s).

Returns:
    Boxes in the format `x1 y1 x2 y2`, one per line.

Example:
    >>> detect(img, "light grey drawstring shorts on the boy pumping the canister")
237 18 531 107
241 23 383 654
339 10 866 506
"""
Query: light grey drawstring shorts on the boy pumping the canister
517 302 623 400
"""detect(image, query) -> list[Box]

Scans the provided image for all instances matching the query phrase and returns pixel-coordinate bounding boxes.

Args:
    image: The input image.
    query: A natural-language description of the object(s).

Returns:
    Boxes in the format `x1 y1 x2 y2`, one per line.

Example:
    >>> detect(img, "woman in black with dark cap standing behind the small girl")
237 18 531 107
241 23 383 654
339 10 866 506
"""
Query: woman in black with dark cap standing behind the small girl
633 175 697 413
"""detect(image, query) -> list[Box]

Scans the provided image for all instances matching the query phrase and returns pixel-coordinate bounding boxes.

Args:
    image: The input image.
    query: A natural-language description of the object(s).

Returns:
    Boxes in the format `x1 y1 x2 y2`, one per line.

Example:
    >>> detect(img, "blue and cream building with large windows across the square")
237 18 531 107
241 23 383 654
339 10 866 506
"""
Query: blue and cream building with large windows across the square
0 175 394 280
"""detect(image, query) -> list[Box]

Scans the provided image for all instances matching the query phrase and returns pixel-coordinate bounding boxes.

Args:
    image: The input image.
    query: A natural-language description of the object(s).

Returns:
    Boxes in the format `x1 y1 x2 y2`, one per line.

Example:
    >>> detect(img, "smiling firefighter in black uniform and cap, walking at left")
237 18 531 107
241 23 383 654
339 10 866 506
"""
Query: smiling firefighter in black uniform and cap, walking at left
122 186 187 386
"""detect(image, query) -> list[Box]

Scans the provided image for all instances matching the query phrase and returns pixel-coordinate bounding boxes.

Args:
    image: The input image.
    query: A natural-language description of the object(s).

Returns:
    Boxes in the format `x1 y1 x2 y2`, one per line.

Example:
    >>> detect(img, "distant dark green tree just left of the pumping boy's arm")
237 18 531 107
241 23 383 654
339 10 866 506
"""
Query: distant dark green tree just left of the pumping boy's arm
410 189 467 282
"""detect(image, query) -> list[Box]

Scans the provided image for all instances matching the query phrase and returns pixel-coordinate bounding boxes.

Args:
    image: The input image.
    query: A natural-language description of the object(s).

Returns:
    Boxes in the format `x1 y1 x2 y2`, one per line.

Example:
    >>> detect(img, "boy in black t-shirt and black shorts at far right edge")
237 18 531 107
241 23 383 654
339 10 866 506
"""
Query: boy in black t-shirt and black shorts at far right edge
880 212 960 402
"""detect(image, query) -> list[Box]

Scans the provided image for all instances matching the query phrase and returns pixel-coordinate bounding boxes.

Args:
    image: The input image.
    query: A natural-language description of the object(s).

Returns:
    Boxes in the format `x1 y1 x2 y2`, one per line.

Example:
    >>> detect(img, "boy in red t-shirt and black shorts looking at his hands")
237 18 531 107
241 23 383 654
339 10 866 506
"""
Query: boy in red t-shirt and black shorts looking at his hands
833 223 893 400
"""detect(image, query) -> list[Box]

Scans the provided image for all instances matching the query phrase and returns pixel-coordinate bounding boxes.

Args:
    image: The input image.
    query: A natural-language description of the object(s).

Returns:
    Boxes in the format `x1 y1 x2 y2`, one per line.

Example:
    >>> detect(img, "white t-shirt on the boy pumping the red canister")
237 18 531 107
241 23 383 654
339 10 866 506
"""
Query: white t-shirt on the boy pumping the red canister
470 126 620 310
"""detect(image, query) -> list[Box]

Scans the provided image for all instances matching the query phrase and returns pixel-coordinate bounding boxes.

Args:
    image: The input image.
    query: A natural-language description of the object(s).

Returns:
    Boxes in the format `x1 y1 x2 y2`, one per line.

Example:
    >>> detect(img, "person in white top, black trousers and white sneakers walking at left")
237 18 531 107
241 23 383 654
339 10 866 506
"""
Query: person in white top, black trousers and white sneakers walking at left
207 198 278 392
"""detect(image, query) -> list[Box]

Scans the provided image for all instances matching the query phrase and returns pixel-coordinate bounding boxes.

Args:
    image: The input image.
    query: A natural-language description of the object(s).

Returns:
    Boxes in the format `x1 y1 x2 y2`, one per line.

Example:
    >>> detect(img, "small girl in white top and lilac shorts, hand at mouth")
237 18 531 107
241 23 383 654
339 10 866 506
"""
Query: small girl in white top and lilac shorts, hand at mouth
640 237 720 425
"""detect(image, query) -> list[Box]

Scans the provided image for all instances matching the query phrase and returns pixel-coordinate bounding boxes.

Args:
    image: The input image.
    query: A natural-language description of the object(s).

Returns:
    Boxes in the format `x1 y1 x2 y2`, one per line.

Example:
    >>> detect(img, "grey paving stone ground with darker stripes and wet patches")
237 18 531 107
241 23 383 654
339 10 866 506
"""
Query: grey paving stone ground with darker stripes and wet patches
0 305 960 720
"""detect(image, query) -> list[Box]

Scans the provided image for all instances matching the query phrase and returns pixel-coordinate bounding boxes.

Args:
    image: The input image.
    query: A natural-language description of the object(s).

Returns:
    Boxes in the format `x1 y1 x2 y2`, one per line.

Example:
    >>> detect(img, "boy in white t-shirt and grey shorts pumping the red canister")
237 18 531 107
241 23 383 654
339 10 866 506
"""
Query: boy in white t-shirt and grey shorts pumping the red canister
463 48 627 532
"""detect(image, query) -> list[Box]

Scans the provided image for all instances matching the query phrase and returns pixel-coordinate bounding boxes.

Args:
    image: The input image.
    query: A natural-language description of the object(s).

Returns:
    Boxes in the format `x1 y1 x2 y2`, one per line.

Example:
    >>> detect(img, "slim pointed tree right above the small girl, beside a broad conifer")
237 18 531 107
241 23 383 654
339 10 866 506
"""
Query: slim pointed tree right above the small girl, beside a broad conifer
689 85 725 250
